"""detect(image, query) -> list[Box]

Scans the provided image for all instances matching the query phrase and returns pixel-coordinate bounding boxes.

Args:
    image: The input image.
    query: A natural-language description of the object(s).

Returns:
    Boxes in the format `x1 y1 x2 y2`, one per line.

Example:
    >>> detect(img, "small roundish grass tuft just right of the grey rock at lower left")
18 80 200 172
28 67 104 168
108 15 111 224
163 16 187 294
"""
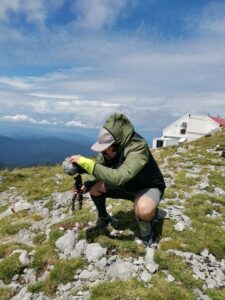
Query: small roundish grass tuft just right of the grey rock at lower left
32 244 58 272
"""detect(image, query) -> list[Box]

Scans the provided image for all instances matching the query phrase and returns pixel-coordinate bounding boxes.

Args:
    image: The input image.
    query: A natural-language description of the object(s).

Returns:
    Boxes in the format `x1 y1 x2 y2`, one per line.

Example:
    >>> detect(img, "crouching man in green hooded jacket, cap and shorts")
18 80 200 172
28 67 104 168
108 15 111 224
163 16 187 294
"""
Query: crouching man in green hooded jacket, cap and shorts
70 113 165 246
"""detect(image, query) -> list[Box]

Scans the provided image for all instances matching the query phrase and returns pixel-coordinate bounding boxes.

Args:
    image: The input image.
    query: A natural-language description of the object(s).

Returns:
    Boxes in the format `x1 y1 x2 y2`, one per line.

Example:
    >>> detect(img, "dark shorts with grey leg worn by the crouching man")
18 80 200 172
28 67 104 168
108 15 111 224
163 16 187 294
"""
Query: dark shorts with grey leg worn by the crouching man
105 184 163 206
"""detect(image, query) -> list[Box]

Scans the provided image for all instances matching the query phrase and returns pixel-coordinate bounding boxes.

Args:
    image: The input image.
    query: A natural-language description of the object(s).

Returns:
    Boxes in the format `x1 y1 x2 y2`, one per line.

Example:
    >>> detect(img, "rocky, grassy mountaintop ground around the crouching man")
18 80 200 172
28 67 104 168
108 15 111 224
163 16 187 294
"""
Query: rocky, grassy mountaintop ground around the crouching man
0 127 225 300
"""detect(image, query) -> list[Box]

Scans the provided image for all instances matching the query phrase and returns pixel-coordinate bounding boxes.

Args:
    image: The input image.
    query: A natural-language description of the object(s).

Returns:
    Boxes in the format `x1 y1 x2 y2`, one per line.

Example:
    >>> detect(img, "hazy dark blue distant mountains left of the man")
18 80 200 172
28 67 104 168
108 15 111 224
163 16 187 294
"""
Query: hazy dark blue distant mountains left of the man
0 135 93 167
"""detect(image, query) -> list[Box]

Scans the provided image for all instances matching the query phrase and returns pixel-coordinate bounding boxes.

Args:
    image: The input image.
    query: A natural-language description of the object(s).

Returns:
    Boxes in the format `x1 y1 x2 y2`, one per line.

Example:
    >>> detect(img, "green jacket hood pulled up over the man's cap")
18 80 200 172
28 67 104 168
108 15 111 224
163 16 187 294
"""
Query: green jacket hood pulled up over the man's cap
103 113 134 152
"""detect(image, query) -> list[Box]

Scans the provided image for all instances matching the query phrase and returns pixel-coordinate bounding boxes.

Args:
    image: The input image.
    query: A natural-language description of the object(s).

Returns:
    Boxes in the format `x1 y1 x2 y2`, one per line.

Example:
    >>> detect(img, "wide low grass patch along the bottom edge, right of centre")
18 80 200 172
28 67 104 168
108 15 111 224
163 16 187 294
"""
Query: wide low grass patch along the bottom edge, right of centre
90 277 196 300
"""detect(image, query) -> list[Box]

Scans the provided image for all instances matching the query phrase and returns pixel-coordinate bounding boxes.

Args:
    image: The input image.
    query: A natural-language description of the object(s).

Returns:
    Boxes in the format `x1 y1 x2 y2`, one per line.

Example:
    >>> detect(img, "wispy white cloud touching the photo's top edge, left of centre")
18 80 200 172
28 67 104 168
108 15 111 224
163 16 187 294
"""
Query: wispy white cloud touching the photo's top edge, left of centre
74 0 128 30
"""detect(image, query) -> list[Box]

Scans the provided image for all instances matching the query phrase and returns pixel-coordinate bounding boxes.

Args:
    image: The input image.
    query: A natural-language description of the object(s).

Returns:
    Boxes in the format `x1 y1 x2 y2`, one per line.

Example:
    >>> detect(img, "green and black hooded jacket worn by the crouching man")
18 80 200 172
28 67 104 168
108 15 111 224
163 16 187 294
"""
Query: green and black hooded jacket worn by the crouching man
87 113 165 192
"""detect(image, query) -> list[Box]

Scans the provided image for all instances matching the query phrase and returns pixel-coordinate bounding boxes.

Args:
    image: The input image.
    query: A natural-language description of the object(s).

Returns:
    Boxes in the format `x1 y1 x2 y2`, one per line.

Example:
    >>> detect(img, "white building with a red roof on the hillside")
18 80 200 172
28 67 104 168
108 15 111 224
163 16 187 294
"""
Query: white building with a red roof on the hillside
152 114 225 148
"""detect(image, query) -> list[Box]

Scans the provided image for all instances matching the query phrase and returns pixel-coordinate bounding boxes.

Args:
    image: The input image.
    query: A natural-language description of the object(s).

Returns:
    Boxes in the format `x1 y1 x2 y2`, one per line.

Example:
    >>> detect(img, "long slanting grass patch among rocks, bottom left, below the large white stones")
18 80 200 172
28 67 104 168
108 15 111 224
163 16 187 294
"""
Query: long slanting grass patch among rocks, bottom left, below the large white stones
28 258 85 296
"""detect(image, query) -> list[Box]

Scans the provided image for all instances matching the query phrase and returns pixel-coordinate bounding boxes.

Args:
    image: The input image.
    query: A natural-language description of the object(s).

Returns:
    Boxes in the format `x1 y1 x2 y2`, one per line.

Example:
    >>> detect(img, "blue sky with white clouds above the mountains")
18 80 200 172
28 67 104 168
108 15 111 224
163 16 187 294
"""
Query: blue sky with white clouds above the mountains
0 0 225 138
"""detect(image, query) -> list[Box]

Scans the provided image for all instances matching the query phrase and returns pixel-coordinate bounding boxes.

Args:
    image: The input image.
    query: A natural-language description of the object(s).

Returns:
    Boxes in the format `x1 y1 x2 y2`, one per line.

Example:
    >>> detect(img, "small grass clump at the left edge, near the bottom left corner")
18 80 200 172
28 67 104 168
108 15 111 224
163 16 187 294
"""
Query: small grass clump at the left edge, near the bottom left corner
0 253 23 284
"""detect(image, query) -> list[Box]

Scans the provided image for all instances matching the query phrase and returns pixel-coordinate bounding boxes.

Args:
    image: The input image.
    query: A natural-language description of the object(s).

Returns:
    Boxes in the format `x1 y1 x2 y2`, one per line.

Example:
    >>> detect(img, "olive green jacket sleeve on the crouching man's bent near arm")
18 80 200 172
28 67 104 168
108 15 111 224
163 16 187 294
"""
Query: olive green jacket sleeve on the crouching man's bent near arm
93 149 149 186
